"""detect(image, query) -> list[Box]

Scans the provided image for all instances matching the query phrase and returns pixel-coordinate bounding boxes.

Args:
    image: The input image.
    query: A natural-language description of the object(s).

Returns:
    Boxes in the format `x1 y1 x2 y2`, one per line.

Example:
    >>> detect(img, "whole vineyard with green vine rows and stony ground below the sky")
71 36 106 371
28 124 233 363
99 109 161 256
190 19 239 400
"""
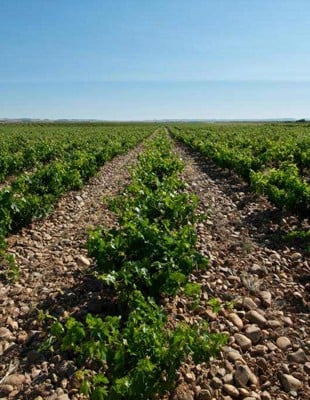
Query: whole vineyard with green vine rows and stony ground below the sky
0 123 310 400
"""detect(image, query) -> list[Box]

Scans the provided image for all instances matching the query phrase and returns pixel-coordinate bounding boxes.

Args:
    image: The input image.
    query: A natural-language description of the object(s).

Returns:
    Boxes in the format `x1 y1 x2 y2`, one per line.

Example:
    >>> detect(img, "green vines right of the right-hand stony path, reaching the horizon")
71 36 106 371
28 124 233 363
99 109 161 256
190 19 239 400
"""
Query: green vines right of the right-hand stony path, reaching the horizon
170 124 310 217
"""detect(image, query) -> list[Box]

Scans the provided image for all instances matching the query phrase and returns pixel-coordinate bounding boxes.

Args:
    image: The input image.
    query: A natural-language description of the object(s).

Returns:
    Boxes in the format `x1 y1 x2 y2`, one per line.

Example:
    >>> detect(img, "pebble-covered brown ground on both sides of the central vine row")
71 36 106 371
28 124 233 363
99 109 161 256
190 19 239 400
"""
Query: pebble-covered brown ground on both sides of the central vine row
0 138 310 400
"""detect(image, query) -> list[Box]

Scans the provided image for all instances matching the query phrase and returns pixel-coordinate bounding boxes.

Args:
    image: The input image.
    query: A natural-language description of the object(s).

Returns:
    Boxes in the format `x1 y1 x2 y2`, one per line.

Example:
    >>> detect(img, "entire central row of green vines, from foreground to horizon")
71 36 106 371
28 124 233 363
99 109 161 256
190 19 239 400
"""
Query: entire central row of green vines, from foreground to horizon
50 130 226 400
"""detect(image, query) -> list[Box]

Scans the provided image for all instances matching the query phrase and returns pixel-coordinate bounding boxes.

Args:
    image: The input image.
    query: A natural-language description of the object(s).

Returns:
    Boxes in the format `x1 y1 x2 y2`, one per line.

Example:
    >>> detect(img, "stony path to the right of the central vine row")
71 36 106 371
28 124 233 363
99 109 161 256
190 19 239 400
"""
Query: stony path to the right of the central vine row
168 141 310 400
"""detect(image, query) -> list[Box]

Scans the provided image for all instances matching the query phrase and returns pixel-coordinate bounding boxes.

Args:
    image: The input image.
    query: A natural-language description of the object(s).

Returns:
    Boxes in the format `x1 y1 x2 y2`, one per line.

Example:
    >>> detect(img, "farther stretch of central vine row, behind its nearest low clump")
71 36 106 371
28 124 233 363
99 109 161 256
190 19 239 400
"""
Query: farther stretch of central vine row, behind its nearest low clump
87 136 207 297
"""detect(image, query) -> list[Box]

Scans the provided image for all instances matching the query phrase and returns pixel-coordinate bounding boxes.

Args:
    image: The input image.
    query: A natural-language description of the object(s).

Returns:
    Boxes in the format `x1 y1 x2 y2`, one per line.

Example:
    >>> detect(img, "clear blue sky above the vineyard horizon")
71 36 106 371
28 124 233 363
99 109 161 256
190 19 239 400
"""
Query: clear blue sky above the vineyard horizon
0 0 310 120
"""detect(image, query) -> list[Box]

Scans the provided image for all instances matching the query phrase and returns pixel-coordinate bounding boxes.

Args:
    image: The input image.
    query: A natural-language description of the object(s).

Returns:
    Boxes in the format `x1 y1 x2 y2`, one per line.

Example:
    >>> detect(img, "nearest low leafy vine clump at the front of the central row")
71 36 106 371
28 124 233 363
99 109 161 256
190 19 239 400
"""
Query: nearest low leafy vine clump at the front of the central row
52 291 226 400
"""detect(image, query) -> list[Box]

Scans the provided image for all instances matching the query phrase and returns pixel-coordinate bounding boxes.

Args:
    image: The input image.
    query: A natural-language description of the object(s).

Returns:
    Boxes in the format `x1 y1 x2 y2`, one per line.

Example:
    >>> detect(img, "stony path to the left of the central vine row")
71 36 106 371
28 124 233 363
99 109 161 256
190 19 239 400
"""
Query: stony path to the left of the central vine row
0 145 143 400
